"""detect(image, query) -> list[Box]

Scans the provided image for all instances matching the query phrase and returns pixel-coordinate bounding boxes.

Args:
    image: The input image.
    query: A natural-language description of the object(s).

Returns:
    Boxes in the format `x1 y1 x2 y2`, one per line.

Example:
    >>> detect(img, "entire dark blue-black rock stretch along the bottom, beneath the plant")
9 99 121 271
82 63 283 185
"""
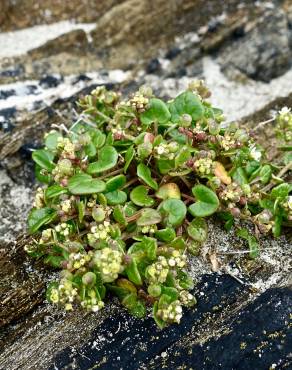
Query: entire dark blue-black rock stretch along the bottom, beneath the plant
50 274 292 370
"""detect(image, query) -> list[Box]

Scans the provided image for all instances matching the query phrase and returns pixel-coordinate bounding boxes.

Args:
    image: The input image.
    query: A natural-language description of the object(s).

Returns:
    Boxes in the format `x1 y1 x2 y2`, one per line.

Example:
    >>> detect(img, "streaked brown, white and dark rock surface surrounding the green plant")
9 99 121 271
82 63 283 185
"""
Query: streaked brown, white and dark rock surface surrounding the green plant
0 0 292 370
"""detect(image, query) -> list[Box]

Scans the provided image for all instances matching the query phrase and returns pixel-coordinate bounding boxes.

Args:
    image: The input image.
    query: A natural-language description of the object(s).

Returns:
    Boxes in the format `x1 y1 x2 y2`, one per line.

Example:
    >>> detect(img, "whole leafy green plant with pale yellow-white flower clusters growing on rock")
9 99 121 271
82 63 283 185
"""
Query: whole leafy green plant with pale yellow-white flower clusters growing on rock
26 82 292 328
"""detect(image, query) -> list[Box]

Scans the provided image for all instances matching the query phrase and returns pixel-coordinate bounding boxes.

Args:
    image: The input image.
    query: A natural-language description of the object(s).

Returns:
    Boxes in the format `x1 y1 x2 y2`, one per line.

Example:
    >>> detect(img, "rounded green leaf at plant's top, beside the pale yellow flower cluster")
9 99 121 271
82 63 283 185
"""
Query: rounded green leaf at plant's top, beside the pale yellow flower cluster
140 98 170 125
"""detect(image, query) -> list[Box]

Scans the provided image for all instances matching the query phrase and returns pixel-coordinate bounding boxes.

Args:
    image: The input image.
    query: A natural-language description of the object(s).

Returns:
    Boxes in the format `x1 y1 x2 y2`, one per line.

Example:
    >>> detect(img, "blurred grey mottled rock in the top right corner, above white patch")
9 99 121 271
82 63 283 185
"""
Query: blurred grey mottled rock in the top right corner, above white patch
219 9 292 82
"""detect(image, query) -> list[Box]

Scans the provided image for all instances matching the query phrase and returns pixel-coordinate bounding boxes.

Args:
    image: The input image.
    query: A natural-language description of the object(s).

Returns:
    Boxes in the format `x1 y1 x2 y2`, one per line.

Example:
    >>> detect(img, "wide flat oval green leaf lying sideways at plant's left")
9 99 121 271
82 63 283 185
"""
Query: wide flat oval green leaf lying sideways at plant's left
68 173 105 194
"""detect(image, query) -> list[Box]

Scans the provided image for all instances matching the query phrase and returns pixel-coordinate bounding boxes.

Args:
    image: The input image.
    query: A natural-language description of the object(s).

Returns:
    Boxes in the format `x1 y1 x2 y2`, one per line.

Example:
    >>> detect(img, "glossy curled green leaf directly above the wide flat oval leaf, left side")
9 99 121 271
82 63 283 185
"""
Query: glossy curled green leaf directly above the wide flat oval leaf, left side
87 145 118 174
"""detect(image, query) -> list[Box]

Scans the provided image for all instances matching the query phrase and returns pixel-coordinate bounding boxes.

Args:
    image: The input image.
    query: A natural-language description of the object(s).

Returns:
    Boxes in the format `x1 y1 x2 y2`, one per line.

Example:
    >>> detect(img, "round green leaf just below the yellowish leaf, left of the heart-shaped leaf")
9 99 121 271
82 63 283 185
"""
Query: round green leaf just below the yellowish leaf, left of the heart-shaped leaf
159 199 187 227
